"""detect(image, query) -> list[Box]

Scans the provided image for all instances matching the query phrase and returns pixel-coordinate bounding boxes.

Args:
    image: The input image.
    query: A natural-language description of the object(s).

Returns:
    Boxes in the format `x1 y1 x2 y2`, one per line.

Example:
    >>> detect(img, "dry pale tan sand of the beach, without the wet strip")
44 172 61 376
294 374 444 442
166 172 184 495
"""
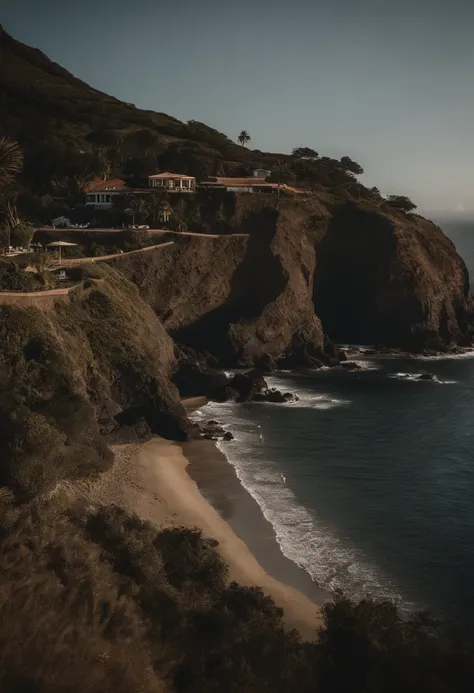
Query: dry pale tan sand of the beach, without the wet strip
63 438 321 639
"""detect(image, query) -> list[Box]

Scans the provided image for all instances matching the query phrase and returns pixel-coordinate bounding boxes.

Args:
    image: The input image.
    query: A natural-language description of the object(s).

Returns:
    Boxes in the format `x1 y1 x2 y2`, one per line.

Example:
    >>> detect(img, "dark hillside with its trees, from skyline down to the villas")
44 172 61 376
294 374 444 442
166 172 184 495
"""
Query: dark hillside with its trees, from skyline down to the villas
0 27 368 198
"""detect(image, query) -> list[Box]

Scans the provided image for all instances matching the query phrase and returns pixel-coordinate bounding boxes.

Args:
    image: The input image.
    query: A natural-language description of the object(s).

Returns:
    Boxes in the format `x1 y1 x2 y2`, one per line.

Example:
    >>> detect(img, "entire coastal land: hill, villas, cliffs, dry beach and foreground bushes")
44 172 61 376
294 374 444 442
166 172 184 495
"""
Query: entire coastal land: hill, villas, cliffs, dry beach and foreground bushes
0 27 472 693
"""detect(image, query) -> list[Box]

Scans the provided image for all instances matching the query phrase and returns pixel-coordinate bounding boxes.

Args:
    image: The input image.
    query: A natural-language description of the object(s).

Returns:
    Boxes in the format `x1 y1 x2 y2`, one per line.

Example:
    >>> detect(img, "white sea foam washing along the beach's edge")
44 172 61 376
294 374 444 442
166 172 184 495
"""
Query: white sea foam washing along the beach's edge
193 394 412 607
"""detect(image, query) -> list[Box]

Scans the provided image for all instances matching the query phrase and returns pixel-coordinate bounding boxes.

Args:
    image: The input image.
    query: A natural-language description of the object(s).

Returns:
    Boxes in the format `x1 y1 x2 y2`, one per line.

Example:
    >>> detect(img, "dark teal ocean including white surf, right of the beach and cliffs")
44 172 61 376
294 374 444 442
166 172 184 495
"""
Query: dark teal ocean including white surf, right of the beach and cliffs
191 223 474 631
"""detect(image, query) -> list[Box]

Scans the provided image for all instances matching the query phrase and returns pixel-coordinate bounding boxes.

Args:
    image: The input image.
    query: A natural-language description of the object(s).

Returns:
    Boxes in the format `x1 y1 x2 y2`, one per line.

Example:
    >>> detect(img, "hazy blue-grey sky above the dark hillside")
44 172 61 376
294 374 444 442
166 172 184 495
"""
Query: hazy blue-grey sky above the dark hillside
0 0 474 214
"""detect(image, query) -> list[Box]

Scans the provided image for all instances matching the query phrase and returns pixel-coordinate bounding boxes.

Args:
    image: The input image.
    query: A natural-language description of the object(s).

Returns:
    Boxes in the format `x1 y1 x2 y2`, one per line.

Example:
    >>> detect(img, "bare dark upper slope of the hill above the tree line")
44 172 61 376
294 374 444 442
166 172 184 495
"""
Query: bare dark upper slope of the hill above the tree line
0 23 262 187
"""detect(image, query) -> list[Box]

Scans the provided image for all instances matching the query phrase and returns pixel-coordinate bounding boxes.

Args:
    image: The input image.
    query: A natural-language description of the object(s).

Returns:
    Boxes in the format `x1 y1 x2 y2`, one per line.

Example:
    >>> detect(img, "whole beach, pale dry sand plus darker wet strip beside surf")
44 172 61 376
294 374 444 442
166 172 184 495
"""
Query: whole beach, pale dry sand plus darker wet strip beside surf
62 438 324 639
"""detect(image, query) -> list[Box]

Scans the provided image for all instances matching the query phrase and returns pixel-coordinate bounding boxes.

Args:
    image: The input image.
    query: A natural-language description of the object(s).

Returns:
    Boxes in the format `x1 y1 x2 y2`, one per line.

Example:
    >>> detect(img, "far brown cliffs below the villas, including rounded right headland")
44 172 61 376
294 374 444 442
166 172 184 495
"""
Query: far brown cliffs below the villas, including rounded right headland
114 195 470 360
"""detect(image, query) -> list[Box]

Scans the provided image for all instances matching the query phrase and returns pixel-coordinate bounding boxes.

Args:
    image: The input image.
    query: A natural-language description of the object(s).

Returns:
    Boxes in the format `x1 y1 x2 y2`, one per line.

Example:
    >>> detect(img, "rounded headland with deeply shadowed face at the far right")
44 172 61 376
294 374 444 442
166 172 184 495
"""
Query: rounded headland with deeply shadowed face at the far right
314 204 469 351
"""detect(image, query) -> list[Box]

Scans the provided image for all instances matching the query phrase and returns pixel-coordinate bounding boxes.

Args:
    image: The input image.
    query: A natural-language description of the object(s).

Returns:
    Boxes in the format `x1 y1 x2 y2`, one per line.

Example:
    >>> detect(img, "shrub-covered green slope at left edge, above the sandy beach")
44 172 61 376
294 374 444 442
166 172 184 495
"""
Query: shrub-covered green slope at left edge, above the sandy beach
0 306 112 497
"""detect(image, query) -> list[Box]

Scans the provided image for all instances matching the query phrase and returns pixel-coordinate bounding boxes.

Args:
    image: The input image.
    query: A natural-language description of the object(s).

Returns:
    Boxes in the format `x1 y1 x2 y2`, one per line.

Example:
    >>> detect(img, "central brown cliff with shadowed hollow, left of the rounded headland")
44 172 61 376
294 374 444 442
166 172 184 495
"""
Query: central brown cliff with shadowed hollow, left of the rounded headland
113 199 327 366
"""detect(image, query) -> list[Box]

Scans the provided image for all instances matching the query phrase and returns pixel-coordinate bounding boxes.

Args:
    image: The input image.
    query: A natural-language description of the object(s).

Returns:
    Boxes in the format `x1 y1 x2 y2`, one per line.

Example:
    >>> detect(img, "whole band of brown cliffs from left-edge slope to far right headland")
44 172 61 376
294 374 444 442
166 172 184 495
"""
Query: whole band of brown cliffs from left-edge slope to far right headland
0 192 471 493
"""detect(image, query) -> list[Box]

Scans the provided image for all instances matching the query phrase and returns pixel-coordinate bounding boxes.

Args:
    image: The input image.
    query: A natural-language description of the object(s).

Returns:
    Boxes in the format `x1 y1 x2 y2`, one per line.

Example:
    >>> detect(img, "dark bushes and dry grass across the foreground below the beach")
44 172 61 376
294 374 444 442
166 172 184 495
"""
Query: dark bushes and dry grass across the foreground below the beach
0 494 474 693
